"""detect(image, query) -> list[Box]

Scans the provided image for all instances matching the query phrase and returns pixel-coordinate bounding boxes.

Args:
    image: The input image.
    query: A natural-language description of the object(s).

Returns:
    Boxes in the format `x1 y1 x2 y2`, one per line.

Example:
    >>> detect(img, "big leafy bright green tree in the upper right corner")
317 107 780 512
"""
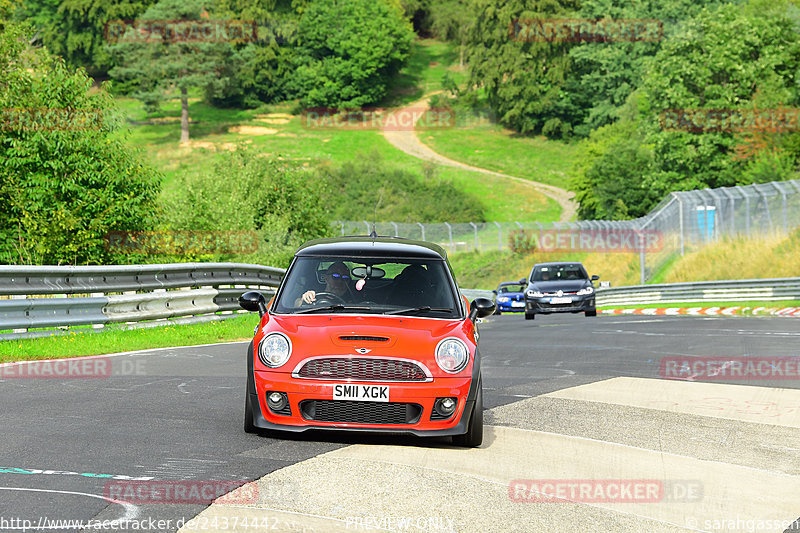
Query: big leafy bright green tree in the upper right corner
644 5 800 195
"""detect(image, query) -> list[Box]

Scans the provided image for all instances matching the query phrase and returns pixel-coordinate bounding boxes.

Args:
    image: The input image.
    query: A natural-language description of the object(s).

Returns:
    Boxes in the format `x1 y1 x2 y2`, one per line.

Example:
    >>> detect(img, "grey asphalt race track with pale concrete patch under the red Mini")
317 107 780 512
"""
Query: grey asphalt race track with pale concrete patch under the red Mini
0 314 800 532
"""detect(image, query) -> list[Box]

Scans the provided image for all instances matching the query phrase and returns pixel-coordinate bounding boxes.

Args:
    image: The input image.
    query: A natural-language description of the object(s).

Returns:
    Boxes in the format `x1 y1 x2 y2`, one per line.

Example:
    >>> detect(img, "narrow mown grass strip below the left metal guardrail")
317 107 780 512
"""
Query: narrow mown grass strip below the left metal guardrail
0 314 258 363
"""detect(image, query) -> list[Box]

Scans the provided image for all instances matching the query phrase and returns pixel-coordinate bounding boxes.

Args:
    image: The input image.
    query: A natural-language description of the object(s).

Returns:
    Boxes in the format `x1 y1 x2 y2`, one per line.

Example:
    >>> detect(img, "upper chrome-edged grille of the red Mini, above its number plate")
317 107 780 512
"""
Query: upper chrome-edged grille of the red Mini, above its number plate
297 357 428 381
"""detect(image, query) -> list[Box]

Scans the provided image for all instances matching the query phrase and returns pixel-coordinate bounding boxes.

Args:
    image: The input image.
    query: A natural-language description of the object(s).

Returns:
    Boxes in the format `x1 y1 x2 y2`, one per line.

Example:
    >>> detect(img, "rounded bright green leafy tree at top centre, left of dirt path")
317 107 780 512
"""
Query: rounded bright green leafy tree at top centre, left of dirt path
292 0 414 108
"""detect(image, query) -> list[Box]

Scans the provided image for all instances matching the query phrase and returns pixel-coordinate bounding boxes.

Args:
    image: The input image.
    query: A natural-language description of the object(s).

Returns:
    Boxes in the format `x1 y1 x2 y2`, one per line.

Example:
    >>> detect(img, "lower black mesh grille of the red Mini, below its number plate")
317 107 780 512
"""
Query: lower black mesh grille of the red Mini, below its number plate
300 400 422 424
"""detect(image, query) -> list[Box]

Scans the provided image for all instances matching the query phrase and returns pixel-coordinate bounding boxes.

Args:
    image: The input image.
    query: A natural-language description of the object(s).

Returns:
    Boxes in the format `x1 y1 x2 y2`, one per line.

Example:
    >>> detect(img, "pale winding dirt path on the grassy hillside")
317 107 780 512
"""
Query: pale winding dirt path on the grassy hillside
382 93 578 222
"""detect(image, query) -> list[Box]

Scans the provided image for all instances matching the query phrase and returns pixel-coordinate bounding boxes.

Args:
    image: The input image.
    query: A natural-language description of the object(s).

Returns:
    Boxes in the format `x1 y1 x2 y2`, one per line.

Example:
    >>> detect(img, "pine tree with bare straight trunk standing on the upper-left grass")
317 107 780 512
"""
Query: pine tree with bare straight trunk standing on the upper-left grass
110 0 241 142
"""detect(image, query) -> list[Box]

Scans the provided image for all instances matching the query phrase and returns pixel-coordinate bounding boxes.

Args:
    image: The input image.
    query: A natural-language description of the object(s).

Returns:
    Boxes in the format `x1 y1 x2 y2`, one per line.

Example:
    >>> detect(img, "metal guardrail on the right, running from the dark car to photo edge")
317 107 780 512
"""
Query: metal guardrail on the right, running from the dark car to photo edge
595 278 800 306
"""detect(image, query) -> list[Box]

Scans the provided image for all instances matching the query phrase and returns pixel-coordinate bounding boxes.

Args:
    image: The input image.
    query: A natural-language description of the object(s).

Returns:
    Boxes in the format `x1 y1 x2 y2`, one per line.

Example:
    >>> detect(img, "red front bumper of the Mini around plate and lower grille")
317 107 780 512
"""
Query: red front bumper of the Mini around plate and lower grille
249 371 477 436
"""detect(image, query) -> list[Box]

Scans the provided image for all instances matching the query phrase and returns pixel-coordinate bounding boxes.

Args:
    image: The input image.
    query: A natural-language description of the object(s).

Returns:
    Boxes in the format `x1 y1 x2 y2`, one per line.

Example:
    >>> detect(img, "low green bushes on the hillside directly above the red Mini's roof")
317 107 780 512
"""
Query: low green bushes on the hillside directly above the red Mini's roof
316 155 484 222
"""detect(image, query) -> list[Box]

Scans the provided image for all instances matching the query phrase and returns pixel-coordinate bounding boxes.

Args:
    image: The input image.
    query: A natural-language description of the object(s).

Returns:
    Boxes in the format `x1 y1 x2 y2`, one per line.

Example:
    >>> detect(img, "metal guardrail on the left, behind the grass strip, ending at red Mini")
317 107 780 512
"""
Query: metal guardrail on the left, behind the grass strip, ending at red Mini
0 263 285 338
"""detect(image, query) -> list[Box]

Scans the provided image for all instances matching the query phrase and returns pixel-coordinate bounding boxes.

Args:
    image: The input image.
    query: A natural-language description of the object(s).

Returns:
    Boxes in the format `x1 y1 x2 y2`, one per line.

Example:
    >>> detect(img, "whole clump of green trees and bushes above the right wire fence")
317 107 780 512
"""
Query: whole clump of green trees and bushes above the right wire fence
573 5 800 218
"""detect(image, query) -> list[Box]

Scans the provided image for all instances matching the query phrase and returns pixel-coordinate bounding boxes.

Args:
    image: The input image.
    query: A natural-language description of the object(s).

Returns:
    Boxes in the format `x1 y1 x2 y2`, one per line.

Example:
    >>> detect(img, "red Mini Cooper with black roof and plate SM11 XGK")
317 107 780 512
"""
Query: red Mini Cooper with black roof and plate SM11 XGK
239 236 494 446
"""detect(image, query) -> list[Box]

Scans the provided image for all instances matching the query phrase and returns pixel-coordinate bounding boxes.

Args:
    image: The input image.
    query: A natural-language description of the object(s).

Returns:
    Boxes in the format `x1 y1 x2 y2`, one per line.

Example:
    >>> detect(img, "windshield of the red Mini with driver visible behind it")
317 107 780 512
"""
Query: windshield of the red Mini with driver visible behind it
273 257 461 318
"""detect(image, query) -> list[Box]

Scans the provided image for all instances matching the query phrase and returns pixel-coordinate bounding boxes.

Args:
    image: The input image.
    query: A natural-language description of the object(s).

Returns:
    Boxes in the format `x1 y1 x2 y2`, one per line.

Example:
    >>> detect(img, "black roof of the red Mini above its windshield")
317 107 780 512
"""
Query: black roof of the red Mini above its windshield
295 235 447 260
